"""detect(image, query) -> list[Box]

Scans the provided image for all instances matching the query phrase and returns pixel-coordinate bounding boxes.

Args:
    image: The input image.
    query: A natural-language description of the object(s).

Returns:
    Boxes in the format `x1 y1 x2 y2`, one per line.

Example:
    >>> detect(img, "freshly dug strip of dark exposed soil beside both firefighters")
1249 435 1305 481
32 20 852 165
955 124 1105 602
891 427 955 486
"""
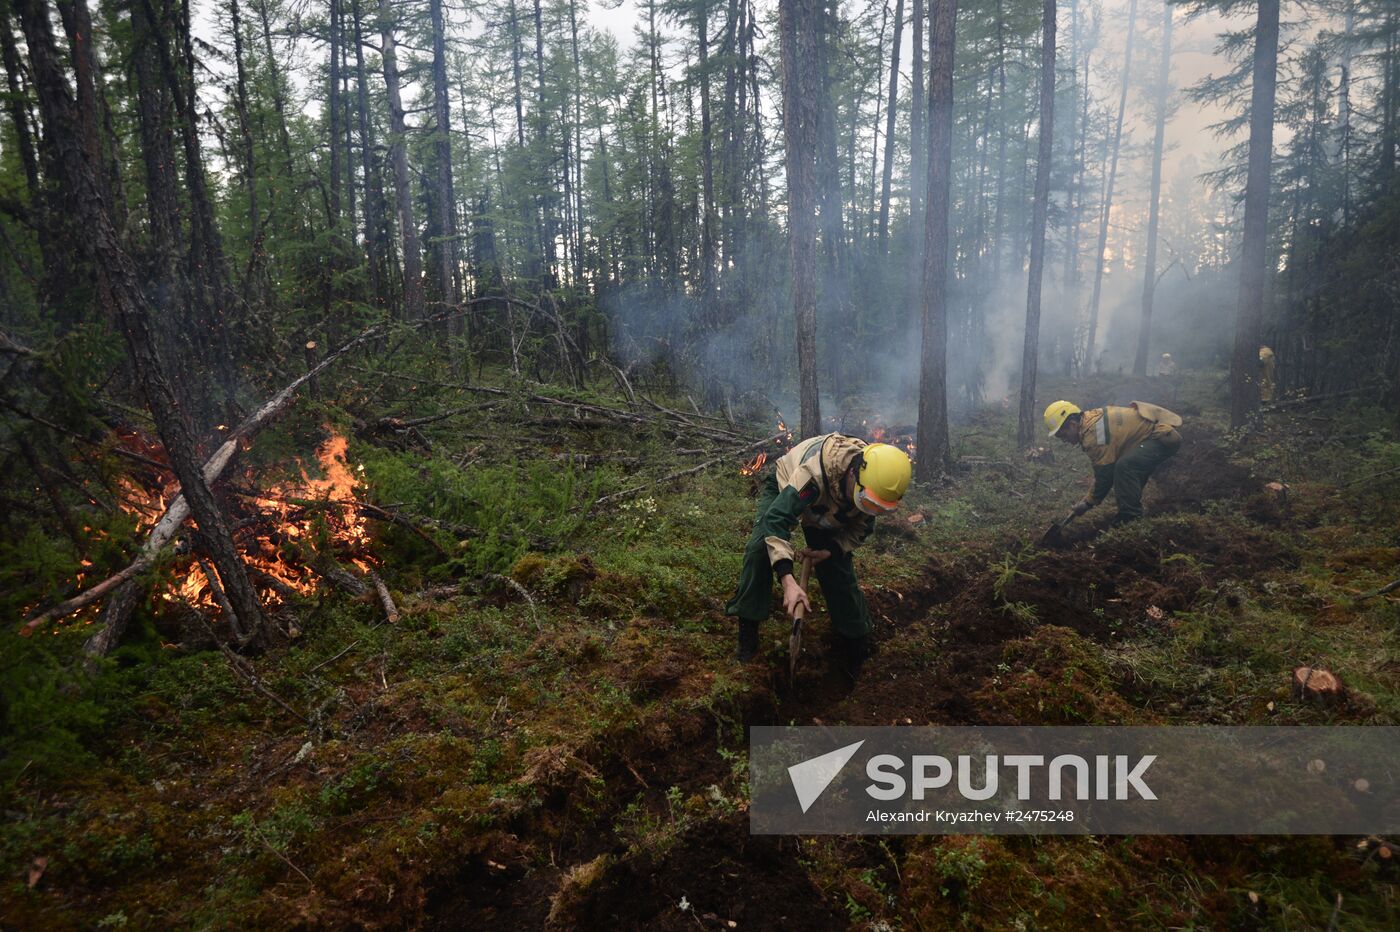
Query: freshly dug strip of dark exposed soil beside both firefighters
427 435 1294 929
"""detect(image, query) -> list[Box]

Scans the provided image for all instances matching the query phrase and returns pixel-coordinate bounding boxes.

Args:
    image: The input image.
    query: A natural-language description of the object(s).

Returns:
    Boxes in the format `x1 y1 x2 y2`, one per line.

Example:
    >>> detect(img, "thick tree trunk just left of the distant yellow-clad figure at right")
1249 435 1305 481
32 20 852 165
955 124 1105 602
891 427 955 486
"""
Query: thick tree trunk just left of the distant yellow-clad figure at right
1229 0 1278 427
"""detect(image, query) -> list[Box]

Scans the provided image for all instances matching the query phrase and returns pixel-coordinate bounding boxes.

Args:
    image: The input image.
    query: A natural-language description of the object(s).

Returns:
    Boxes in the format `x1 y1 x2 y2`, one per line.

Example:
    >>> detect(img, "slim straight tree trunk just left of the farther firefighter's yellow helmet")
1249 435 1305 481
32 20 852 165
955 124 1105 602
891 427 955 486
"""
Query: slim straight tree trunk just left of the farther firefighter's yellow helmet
1016 0 1052 446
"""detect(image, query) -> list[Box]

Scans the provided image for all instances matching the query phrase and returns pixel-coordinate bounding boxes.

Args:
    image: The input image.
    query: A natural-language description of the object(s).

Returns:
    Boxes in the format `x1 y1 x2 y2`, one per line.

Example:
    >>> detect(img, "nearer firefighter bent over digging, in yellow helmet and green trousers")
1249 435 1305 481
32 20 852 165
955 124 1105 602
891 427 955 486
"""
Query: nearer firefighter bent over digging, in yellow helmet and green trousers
725 434 911 679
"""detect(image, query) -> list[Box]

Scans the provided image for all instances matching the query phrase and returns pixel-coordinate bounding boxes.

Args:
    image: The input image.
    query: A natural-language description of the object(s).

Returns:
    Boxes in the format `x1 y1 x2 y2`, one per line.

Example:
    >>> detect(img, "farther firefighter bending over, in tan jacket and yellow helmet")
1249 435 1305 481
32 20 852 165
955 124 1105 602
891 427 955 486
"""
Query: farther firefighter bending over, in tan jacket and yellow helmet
1046 402 1182 523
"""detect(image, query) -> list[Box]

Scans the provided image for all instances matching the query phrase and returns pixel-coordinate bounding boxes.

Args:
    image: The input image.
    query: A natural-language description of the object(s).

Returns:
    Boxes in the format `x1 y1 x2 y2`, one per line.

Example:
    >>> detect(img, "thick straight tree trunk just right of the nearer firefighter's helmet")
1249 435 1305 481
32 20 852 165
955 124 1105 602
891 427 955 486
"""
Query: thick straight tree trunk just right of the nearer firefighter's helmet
914 0 958 483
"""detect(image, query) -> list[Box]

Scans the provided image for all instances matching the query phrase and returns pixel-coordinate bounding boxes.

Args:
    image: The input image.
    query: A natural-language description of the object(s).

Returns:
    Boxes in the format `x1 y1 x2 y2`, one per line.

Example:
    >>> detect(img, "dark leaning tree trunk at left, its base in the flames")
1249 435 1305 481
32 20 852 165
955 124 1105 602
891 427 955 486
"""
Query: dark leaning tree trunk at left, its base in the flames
18 0 262 635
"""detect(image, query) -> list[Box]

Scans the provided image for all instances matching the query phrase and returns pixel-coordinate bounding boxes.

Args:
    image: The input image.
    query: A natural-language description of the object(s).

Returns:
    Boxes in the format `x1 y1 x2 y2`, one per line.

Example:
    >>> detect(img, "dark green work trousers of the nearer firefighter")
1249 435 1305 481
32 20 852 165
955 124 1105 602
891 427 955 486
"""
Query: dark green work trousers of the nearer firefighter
724 473 872 638
